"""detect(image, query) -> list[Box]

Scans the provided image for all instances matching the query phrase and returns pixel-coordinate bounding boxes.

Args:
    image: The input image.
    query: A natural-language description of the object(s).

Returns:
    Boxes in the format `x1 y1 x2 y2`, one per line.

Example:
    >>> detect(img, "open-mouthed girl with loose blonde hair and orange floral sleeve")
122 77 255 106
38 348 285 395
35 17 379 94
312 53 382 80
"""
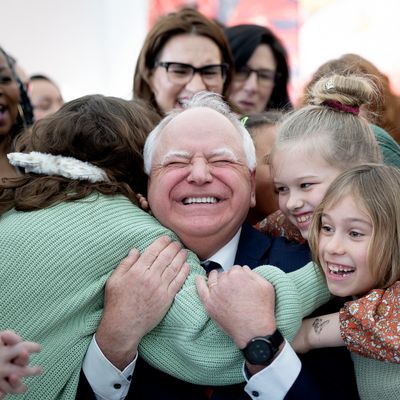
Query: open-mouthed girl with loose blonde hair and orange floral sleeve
294 164 400 400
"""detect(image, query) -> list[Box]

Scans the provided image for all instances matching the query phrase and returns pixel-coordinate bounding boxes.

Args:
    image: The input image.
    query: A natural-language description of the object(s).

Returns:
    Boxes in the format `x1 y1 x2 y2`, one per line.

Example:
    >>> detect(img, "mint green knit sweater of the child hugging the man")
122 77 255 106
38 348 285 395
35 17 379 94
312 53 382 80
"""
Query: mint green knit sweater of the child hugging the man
0 195 329 400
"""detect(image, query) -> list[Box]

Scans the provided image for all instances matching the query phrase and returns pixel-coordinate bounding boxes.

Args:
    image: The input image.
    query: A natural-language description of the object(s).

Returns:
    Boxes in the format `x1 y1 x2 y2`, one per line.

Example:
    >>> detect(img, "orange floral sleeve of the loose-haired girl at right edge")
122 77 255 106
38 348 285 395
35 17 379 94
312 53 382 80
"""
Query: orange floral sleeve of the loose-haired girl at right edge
339 281 400 363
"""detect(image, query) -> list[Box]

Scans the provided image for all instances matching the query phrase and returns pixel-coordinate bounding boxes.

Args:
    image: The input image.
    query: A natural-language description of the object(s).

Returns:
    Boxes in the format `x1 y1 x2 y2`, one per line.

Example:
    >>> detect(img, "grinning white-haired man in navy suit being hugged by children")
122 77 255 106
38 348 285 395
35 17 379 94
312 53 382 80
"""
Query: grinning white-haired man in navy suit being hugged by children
83 92 350 400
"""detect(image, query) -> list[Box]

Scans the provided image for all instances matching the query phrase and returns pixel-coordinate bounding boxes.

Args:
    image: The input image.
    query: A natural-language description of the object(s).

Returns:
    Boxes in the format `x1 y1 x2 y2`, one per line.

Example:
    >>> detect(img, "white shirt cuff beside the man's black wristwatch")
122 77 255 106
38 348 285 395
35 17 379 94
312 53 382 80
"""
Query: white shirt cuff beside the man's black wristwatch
243 341 301 400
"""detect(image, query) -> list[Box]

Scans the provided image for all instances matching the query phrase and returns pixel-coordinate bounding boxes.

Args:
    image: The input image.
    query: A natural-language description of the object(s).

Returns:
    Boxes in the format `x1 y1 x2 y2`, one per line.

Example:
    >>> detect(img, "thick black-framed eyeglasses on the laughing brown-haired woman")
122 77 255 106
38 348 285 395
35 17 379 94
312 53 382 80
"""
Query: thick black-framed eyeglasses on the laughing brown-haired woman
155 61 228 86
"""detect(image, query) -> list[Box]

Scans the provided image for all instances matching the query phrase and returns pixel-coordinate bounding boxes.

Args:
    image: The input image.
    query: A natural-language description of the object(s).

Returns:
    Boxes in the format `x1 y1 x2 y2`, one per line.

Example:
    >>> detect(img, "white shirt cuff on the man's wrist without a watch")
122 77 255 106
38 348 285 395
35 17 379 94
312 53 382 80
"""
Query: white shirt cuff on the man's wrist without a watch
82 335 138 400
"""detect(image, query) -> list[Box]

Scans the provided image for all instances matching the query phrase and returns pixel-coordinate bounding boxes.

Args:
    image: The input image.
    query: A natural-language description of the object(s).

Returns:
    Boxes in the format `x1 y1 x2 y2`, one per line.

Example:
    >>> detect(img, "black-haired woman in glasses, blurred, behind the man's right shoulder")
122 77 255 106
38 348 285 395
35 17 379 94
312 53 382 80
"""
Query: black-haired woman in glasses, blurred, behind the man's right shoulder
225 25 292 115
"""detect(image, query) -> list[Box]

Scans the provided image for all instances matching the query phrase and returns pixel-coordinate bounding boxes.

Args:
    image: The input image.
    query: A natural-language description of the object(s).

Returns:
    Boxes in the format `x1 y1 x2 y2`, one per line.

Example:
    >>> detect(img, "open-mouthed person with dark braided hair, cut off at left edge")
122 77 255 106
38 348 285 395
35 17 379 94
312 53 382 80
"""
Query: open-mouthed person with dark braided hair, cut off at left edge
0 47 33 179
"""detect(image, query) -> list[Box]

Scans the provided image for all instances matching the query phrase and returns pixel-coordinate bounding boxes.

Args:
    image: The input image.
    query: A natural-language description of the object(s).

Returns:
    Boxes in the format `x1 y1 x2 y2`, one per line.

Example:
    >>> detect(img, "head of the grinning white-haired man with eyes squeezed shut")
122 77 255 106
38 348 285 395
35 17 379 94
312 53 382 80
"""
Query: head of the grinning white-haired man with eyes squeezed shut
145 96 255 260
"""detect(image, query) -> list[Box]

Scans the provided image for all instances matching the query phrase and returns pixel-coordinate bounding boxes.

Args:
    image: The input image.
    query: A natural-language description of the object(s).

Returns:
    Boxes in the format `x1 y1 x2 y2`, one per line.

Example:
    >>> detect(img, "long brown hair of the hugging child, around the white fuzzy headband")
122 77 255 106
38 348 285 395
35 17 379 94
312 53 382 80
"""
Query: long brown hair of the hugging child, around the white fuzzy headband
0 95 160 213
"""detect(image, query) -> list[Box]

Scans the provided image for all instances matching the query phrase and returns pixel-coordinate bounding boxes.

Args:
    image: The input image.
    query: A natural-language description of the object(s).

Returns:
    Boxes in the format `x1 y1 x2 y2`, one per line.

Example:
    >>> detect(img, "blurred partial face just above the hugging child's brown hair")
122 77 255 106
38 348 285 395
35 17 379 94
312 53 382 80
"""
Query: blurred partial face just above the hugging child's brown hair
28 74 64 121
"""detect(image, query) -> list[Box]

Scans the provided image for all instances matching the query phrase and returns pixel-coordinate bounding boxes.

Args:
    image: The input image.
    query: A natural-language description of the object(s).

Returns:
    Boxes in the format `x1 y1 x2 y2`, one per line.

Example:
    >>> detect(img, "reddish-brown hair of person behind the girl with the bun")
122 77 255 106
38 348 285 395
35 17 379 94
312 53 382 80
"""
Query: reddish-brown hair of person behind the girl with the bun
302 53 400 143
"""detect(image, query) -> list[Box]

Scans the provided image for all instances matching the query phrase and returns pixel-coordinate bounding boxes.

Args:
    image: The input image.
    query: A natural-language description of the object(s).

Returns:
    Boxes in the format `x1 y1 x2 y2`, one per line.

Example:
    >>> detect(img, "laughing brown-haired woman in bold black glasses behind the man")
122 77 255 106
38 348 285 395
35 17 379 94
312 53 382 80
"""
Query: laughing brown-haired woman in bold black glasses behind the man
133 8 233 114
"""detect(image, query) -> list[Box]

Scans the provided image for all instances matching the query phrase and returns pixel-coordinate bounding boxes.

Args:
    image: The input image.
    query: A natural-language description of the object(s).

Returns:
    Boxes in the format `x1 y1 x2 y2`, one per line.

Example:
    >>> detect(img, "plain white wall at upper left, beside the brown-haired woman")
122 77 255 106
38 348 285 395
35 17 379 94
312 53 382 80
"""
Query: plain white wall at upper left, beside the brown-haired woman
0 0 148 100
